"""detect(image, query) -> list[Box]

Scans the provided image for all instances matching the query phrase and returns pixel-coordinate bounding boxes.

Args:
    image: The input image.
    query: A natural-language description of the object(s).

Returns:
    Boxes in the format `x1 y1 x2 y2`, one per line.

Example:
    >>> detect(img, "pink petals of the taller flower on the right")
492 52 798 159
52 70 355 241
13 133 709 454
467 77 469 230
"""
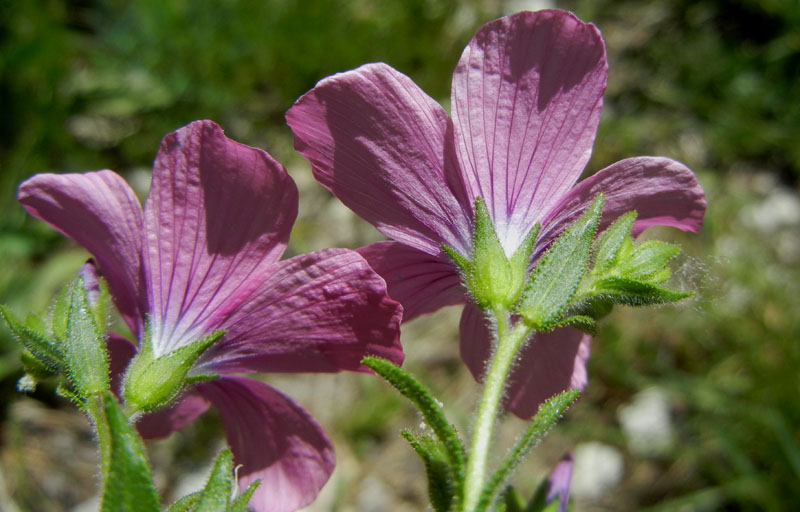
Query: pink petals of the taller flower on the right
286 10 706 417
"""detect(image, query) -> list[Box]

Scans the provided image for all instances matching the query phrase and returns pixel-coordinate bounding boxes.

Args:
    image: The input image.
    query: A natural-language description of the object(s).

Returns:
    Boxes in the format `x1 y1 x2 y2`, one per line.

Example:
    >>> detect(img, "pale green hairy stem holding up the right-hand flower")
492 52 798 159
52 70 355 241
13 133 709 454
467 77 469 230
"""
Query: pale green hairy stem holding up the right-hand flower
463 309 531 512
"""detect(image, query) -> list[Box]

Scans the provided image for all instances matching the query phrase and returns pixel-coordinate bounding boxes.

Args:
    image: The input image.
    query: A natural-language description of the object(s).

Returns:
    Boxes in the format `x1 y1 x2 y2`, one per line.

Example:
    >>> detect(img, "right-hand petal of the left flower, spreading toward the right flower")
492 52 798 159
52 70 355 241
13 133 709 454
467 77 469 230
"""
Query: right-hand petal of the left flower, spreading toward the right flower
201 249 403 373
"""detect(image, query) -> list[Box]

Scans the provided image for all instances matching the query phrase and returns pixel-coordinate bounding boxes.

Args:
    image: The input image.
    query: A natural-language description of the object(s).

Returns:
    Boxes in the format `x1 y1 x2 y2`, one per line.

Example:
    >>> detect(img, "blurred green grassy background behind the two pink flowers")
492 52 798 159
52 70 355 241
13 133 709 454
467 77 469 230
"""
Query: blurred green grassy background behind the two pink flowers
0 0 800 512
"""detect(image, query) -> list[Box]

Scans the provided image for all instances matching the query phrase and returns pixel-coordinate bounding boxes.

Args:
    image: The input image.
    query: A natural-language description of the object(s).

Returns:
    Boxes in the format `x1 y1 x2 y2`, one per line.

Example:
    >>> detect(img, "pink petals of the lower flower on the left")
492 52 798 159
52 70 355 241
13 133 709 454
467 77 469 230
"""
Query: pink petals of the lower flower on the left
19 121 403 512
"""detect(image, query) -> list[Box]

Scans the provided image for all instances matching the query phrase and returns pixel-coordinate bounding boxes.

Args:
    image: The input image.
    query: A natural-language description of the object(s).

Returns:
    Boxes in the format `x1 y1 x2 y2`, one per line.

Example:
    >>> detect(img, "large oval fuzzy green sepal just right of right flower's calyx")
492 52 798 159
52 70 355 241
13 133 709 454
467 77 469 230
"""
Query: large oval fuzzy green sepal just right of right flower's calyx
518 194 603 332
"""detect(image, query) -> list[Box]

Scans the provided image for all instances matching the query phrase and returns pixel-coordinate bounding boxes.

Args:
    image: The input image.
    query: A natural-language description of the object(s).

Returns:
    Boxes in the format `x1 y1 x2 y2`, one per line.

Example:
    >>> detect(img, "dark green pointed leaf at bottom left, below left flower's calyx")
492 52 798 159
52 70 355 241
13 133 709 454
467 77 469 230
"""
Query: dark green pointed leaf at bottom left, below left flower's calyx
98 393 161 512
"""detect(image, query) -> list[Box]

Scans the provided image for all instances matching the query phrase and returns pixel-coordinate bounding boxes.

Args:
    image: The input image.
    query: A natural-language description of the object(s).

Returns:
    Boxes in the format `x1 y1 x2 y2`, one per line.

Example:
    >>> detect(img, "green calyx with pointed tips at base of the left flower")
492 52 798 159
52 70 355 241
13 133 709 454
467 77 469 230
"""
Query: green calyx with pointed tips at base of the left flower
122 327 225 412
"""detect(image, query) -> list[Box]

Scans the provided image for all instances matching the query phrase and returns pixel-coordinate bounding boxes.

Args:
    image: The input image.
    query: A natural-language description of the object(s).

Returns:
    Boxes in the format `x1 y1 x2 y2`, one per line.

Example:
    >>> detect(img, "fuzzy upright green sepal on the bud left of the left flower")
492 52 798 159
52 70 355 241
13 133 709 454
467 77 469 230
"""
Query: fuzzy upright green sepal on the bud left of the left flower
64 277 110 398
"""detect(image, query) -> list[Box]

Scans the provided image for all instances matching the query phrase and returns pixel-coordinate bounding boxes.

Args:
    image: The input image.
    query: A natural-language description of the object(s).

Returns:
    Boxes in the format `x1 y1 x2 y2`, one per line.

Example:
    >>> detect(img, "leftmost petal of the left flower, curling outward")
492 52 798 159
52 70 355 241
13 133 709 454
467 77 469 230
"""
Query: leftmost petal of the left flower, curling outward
18 171 144 333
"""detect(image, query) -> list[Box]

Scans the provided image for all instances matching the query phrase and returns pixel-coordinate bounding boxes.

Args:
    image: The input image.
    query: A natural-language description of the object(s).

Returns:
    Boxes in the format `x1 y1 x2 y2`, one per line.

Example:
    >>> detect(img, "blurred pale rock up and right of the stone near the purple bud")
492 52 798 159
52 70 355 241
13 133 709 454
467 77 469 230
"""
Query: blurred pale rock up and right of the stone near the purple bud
617 388 675 456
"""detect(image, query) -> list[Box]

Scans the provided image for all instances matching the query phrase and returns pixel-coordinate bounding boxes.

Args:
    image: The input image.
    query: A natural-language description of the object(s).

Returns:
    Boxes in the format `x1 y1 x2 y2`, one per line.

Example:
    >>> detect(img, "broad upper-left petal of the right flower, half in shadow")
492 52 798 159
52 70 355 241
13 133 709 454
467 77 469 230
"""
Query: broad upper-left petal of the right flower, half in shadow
286 64 470 255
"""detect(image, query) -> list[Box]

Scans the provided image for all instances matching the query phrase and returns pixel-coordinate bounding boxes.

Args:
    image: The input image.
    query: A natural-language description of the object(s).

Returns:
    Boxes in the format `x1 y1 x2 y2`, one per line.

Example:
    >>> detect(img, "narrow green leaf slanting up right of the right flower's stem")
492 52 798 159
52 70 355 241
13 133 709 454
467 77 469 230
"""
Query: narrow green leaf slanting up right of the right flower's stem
475 389 580 512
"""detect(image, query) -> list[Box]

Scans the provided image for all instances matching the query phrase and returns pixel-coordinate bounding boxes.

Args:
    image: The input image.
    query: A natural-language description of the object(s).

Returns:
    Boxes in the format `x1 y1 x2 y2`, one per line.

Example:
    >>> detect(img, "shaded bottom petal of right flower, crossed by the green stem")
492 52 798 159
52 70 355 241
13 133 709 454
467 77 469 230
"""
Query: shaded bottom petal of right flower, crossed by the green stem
460 303 591 418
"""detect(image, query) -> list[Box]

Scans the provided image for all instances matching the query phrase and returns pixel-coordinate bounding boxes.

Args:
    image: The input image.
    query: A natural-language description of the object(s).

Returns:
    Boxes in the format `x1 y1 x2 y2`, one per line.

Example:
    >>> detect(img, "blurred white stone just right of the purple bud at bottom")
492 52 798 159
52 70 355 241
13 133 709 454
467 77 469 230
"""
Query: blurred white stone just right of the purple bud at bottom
570 442 625 500
